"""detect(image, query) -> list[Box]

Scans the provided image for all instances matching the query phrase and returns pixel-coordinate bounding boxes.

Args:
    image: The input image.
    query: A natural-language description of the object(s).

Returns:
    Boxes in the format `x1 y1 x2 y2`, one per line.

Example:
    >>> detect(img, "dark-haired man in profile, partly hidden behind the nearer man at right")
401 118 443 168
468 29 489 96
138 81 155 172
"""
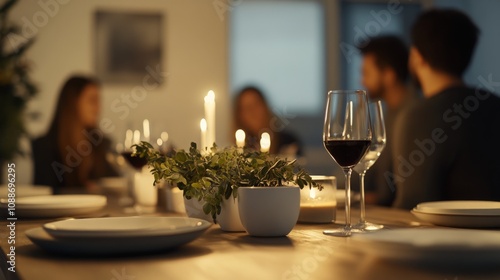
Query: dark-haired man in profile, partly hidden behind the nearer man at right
359 36 417 206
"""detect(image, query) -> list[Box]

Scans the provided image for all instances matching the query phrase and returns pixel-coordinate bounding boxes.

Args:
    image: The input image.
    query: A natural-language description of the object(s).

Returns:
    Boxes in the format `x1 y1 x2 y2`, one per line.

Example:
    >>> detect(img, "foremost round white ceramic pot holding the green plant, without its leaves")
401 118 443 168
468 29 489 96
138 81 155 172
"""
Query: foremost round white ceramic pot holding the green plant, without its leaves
238 186 300 236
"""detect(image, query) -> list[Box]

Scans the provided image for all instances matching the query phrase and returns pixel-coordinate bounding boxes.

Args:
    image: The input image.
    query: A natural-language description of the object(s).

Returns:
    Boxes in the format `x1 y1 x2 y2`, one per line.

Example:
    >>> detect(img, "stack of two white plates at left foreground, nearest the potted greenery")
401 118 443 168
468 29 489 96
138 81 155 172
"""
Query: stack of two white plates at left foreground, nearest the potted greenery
26 217 211 256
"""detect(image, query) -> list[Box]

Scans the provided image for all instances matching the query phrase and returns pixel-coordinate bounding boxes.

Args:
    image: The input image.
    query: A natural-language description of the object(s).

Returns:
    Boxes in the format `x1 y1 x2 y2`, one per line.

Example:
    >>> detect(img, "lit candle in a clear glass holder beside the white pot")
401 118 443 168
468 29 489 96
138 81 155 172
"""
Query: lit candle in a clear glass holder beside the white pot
299 176 337 223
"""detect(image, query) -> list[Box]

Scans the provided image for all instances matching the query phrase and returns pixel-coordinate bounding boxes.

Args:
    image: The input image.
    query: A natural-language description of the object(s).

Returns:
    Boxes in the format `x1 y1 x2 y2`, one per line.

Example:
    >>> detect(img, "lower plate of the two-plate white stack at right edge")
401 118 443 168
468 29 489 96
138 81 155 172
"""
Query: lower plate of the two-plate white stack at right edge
411 209 500 228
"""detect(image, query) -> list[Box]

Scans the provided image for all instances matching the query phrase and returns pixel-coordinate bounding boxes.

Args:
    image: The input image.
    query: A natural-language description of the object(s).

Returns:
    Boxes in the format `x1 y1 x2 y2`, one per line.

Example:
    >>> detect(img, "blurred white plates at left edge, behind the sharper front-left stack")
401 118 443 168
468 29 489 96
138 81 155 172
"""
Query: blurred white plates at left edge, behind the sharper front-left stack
0 194 106 218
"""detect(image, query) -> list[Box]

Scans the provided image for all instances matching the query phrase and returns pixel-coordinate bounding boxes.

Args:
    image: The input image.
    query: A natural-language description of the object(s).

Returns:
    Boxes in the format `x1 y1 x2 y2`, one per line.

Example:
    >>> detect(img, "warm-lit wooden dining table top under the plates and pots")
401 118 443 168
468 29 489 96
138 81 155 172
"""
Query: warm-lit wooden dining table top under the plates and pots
0 195 500 280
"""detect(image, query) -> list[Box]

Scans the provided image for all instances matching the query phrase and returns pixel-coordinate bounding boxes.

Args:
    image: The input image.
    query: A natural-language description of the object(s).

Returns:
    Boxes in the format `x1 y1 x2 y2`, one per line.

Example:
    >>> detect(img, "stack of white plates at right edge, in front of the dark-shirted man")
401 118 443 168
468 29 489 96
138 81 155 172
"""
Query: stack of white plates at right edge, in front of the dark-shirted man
411 200 500 228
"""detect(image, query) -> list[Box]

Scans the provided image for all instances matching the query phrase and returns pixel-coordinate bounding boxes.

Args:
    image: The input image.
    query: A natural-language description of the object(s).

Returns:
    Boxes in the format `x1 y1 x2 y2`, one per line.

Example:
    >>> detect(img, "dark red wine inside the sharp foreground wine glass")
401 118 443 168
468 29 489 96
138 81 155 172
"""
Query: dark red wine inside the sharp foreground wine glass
324 140 371 168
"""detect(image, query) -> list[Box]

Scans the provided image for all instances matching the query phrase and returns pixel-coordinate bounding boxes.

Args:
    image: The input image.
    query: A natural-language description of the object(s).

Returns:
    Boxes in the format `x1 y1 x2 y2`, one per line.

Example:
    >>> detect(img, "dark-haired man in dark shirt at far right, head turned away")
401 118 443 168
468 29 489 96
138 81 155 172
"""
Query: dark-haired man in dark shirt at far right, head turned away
392 9 500 209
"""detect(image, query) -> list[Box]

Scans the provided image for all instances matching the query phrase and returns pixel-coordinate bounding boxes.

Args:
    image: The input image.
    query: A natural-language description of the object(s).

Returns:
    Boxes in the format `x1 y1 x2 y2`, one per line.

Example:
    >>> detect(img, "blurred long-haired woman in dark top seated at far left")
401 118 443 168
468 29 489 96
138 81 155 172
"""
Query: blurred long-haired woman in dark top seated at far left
32 76 118 193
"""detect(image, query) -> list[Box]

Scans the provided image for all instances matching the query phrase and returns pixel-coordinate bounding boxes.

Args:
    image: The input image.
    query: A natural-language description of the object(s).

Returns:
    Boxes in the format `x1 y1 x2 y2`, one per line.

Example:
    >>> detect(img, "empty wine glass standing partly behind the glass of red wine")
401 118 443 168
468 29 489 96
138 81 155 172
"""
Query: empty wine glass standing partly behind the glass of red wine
353 101 387 231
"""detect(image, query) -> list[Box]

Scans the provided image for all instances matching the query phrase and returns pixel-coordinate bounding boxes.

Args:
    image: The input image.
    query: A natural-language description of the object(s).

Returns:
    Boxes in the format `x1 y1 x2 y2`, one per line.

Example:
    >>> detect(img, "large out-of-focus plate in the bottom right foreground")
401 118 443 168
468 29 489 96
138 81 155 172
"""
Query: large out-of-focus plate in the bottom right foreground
350 228 500 266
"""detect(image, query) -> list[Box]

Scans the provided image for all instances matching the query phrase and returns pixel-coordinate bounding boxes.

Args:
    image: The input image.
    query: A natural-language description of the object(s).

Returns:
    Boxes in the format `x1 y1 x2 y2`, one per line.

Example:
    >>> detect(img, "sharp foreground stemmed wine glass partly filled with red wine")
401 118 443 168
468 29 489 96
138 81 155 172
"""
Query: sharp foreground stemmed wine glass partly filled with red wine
323 90 372 237
